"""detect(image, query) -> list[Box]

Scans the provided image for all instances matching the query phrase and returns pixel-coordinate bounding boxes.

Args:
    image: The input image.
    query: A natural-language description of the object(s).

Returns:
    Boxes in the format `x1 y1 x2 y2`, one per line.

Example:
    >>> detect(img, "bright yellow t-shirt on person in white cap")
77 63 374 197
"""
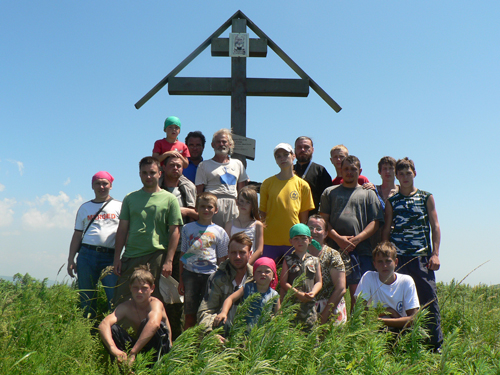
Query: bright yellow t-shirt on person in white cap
260 176 314 246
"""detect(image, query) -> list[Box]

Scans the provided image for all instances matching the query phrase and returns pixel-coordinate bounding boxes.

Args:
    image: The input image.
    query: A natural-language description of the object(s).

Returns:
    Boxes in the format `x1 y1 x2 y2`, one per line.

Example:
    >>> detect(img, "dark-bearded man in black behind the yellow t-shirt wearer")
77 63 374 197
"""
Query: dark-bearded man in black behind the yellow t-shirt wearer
293 136 332 216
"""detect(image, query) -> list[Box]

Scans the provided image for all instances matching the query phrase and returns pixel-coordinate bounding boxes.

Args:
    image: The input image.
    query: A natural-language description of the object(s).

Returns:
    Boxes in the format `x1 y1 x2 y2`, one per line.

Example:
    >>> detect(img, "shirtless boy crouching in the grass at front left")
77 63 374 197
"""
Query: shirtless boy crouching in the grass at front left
99 266 172 365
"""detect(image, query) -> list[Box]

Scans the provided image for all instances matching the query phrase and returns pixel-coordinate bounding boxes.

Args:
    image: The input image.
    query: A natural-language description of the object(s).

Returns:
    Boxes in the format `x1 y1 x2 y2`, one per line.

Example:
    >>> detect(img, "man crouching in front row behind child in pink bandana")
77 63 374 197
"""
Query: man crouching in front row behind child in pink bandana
198 232 253 332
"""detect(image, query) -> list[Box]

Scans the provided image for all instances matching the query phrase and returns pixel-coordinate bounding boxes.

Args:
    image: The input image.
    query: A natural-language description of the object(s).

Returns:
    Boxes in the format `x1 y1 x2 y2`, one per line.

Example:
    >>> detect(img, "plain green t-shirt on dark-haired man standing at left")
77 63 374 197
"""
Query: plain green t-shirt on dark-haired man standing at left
120 189 183 258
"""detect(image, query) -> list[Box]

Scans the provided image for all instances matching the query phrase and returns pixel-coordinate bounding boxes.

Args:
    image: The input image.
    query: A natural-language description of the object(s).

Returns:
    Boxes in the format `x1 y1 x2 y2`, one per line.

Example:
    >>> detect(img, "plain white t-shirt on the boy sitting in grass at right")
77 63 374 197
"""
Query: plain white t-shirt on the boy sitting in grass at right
354 271 420 316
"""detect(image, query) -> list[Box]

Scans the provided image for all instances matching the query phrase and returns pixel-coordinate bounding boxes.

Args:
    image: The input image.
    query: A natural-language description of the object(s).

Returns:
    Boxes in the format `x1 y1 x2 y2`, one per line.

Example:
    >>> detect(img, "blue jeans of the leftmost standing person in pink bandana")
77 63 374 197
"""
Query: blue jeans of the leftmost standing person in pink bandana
76 244 118 318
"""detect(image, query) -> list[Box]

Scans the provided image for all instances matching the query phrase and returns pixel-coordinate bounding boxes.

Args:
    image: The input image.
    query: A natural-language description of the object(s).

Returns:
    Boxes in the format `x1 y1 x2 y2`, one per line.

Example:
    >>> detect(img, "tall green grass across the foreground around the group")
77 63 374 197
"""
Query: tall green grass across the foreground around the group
0 275 500 375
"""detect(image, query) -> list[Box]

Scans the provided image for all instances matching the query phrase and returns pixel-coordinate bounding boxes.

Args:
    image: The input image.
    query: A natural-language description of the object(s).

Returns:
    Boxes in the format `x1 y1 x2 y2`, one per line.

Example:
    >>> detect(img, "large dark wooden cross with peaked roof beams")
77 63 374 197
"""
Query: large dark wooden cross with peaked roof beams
135 11 342 166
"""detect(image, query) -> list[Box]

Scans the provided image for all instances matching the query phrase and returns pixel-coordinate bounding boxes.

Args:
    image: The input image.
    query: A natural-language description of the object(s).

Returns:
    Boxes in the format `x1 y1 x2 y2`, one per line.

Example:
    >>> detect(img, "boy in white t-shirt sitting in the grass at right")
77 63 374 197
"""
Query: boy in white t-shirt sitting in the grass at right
355 242 420 328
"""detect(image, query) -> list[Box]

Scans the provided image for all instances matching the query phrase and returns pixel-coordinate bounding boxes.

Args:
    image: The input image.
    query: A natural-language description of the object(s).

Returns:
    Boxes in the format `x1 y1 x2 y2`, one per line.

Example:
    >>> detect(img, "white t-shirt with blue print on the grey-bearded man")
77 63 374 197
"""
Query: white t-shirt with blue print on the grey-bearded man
195 159 248 198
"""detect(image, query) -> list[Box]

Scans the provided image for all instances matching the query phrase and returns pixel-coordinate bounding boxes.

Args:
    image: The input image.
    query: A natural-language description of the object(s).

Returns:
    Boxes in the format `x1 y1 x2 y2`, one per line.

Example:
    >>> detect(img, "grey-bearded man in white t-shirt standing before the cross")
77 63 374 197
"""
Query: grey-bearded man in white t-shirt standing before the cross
195 129 248 228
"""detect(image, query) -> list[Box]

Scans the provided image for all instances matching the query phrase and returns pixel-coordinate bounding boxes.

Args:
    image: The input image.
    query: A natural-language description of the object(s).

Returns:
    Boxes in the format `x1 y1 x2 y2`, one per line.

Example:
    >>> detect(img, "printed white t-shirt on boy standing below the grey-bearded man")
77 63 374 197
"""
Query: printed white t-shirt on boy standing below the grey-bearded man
181 221 229 275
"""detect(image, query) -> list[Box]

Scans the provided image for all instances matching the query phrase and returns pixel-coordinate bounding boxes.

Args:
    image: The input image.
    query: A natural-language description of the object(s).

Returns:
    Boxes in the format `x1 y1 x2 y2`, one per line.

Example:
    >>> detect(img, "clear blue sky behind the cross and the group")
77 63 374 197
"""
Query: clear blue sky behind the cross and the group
0 0 500 284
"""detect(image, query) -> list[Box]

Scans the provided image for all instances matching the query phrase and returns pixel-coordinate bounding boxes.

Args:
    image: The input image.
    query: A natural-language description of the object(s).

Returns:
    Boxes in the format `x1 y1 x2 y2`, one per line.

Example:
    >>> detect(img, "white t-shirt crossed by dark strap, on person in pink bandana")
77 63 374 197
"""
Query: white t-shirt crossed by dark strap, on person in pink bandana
75 199 122 248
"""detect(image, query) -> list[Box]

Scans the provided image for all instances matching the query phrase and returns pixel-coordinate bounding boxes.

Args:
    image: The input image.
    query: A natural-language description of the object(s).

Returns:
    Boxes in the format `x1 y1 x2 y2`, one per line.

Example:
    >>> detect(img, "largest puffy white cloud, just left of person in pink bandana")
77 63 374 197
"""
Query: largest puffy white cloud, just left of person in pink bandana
21 191 83 230
